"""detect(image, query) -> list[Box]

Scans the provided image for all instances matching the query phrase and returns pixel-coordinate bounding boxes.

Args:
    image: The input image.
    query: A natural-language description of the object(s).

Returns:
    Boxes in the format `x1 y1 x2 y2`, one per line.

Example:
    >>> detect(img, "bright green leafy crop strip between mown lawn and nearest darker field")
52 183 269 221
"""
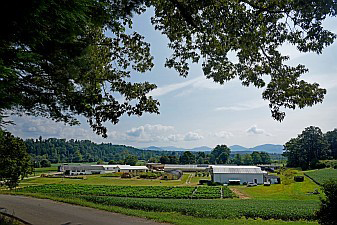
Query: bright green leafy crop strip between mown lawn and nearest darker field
16 184 234 199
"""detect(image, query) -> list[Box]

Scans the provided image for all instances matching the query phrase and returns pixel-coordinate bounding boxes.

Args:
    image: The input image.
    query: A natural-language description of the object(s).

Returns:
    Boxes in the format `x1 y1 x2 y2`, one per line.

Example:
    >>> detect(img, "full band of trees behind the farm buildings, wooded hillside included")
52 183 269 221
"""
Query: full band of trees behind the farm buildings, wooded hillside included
25 137 271 167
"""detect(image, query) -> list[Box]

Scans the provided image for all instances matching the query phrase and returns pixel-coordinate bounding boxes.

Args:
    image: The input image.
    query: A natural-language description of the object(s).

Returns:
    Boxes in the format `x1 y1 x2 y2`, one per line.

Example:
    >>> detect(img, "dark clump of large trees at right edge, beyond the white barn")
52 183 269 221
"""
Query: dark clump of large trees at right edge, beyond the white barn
283 126 337 170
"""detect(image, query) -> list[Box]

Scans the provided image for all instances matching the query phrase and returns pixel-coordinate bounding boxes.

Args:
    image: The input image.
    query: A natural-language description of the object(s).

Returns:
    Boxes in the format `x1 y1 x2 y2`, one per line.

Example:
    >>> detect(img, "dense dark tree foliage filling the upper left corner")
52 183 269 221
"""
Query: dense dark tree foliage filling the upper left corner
0 0 158 136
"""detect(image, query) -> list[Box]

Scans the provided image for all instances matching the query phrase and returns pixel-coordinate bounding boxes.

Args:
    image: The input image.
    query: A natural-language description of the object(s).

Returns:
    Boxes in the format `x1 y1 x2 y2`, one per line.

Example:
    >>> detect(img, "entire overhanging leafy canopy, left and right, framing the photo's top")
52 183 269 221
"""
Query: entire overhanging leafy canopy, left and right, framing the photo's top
0 0 337 136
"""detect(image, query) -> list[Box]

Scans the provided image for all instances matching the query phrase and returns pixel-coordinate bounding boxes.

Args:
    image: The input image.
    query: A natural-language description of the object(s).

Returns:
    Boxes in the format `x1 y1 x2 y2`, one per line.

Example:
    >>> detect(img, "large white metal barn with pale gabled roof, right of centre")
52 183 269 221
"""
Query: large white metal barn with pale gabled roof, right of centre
210 165 266 184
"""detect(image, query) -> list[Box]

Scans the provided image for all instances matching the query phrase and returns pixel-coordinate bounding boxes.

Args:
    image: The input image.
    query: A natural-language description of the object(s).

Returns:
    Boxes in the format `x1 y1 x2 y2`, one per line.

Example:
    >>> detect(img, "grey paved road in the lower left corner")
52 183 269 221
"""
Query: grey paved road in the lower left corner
0 195 167 225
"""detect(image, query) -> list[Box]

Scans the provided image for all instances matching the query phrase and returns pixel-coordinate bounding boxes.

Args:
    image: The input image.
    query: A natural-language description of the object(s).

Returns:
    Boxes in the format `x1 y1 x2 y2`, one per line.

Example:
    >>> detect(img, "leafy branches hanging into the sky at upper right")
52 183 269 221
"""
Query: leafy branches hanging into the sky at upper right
150 0 337 121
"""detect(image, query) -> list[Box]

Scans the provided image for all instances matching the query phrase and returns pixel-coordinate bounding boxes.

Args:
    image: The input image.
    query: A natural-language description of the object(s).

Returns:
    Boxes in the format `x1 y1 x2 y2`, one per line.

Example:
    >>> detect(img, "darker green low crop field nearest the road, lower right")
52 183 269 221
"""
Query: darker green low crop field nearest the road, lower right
81 196 319 220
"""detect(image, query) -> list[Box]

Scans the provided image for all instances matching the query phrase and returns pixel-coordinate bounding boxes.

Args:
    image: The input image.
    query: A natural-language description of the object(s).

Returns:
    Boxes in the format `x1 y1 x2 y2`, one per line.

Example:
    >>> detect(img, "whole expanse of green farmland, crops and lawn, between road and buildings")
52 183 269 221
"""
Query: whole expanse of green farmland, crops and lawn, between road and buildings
7 170 321 225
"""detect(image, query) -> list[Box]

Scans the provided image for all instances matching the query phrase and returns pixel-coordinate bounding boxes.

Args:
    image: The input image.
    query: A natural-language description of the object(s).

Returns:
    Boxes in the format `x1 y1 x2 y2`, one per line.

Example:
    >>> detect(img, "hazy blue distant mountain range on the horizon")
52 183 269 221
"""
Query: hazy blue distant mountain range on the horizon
143 144 283 154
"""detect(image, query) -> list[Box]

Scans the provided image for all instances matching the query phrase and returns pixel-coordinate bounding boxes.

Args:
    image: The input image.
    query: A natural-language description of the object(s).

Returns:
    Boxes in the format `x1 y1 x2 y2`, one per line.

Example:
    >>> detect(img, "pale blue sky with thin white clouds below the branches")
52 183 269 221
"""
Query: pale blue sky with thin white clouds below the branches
7 10 337 148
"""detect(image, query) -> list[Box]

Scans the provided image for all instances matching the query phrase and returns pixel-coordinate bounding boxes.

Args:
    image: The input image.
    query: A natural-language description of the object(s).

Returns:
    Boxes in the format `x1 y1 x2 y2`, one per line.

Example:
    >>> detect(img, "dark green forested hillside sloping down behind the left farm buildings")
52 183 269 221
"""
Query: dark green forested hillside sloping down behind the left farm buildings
25 137 182 163
